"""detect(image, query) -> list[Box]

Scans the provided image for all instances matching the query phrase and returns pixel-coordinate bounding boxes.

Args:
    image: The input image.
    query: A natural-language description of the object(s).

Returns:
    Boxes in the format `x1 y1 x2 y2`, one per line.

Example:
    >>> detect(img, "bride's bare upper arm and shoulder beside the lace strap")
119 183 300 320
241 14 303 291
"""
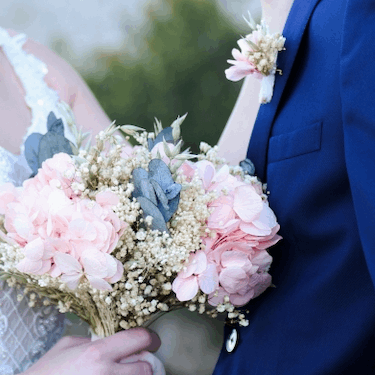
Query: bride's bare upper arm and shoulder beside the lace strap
8 30 111 135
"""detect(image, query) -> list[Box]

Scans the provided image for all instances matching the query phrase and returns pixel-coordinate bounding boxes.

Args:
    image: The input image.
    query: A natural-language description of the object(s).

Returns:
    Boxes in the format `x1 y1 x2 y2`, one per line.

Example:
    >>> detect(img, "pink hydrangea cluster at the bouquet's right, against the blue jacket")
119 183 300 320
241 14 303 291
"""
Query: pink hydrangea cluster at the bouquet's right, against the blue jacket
172 160 281 306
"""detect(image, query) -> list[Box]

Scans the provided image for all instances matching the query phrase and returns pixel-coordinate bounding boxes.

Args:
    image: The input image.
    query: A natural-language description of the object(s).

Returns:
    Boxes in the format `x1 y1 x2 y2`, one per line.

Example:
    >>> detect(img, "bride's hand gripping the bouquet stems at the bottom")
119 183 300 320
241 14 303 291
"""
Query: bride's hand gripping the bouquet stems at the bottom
23 328 161 375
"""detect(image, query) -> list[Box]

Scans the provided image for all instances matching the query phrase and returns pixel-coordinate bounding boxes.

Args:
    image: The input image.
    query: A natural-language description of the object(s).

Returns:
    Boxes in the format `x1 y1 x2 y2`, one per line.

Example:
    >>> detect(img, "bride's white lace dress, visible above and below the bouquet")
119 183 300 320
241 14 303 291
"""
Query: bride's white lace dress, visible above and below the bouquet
0 28 75 375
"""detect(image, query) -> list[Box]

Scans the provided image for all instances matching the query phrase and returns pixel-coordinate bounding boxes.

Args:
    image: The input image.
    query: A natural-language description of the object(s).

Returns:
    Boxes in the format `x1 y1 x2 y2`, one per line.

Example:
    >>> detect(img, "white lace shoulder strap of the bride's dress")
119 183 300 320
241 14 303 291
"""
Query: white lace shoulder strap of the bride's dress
0 27 75 153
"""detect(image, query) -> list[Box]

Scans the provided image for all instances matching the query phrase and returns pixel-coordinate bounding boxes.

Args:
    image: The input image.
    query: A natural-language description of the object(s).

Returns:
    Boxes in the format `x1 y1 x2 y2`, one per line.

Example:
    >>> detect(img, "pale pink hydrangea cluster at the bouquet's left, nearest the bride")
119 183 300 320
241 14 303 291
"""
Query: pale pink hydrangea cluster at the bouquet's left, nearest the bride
0 153 127 290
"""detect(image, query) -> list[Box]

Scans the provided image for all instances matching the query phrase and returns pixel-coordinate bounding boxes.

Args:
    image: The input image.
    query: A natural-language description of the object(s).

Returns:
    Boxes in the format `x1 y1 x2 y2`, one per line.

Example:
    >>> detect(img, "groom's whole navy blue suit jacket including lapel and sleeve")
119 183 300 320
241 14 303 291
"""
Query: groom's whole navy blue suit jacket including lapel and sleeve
214 0 375 375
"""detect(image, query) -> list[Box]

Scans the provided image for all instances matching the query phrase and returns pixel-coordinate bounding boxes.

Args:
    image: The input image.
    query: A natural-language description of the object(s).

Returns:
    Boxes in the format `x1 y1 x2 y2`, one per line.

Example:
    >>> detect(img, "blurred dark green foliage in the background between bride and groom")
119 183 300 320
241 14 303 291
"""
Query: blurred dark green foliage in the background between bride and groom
83 0 241 152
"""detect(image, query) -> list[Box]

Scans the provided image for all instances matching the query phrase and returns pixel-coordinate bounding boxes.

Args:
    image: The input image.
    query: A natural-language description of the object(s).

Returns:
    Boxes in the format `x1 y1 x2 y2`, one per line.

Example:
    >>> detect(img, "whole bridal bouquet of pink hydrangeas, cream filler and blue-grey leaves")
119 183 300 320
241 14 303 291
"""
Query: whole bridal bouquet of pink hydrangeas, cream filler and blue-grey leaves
0 108 281 337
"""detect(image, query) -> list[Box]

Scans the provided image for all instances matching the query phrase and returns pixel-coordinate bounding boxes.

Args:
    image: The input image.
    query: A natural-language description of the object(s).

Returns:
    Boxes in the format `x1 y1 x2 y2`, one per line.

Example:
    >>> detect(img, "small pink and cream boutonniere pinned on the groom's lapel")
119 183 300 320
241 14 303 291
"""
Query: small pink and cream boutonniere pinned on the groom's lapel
225 12 285 104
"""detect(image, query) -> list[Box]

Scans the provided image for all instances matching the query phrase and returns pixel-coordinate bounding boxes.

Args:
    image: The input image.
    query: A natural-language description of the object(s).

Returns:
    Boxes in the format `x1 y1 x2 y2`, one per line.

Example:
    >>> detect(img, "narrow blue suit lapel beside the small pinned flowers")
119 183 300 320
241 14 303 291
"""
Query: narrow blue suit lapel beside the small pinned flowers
247 0 320 182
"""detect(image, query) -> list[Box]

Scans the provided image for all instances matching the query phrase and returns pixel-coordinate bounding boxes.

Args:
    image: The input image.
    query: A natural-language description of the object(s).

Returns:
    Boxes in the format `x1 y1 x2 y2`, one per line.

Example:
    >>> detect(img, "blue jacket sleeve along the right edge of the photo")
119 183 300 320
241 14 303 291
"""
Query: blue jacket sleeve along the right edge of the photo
340 0 375 285
